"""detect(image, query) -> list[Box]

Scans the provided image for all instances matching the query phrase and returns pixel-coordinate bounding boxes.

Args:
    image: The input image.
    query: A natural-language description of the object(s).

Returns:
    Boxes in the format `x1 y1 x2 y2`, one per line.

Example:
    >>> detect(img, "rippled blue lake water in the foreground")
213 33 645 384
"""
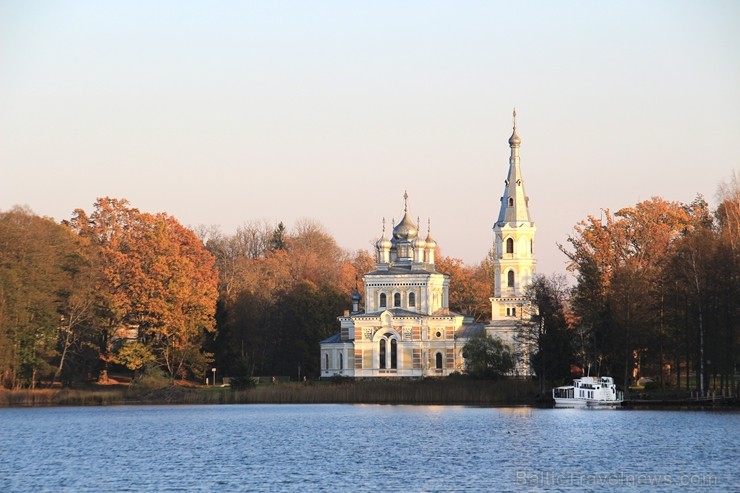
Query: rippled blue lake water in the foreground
0 405 740 492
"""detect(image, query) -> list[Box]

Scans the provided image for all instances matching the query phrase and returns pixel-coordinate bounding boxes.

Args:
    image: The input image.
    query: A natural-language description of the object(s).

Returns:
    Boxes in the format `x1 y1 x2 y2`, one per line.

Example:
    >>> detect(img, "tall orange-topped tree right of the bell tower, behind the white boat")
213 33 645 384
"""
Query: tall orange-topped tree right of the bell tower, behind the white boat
560 198 691 386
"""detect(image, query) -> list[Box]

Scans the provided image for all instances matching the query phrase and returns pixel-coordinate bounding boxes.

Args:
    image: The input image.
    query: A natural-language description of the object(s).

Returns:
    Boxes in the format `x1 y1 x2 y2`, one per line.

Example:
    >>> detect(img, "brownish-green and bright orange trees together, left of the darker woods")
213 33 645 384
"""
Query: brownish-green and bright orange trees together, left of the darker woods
0 198 218 388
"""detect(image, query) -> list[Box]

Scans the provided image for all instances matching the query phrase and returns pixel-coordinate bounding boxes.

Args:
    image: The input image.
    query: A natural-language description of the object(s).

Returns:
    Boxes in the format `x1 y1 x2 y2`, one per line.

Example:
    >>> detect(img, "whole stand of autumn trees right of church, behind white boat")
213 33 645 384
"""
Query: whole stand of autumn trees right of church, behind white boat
555 176 740 393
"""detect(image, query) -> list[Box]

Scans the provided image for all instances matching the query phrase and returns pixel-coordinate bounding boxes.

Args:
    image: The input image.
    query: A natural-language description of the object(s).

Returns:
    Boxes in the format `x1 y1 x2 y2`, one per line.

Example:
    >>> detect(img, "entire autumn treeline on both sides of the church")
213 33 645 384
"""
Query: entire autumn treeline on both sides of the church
0 177 740 391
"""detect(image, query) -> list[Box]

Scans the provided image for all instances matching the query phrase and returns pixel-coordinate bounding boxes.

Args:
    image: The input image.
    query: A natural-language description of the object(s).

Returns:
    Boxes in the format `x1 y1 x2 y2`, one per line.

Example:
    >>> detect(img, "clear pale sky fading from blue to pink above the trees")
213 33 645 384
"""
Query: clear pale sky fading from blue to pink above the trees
0 0 740 275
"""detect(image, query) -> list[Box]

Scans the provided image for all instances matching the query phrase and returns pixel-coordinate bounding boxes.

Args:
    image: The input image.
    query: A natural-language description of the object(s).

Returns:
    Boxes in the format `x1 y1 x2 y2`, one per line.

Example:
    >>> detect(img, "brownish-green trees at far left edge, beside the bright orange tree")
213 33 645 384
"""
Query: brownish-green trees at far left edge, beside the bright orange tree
0 207 84 388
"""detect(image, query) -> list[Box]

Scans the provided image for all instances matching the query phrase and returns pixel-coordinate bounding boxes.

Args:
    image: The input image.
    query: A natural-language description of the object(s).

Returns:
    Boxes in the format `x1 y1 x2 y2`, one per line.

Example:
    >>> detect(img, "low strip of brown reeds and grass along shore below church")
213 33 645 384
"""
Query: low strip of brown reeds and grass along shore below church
0 380 537 407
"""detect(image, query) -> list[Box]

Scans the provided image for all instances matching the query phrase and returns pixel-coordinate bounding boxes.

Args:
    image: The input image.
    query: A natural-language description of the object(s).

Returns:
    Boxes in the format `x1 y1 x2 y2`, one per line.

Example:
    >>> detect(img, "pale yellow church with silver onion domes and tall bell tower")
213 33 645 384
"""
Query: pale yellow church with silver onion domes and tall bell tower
320 111 536 378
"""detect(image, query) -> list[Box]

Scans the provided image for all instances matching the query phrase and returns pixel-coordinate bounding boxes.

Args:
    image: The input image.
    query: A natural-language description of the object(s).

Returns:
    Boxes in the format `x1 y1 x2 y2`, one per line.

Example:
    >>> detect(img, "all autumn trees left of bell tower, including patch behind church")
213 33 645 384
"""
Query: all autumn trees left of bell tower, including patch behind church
0 198 498 388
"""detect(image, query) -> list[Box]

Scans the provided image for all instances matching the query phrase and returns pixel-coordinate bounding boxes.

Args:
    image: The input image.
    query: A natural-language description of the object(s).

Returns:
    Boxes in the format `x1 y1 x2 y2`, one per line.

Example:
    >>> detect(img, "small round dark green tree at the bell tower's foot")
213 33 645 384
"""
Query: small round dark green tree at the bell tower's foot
462 332 514 378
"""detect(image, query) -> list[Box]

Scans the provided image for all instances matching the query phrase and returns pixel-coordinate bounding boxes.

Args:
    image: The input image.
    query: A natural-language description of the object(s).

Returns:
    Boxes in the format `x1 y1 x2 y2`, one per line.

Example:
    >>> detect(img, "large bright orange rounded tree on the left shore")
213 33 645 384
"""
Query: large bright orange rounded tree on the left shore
71 198 218 380
